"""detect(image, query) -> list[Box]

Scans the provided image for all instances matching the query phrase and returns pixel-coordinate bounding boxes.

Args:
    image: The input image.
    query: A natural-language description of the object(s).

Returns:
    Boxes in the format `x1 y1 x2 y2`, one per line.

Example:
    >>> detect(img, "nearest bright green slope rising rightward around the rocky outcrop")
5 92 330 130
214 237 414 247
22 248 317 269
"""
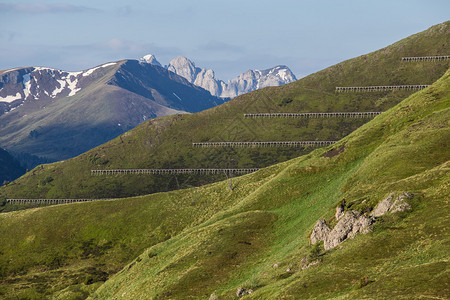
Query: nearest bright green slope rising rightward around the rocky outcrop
89 72 450 299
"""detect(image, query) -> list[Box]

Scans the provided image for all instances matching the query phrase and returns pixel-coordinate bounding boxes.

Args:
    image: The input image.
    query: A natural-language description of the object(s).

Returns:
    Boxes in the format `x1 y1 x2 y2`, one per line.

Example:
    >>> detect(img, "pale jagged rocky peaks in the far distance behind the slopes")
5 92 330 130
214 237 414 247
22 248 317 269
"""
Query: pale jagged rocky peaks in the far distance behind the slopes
167 56 297 98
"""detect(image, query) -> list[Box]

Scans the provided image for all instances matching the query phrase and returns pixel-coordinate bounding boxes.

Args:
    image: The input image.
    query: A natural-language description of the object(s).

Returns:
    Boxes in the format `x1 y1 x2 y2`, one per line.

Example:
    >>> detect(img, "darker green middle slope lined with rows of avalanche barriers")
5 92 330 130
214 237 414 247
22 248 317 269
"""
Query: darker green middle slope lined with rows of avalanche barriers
0 22 450 202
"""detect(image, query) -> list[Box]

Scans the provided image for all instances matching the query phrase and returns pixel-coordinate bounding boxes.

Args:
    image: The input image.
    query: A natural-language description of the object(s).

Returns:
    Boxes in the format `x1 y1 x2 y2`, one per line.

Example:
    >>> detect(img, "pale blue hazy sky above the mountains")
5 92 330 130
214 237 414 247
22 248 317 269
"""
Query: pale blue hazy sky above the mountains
0 0 450 81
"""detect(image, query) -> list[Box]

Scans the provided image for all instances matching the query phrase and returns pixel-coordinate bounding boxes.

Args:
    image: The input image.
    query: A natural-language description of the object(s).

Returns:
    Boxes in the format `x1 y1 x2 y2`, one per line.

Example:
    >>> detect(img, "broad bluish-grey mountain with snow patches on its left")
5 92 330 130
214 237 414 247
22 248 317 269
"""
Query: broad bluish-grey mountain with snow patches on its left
0 60 223 160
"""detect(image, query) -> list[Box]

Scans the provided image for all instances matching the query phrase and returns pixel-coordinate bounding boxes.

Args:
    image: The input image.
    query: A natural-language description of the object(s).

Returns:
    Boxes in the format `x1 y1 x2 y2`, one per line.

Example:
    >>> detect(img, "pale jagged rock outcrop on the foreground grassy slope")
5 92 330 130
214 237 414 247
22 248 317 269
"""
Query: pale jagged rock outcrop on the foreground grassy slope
310 192 414 250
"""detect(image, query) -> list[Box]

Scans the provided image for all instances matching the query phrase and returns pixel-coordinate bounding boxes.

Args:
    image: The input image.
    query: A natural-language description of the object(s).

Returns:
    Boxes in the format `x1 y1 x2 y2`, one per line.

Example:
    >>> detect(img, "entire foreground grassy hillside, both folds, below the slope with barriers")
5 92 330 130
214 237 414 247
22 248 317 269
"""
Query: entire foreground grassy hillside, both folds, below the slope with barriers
0 68 450 299
